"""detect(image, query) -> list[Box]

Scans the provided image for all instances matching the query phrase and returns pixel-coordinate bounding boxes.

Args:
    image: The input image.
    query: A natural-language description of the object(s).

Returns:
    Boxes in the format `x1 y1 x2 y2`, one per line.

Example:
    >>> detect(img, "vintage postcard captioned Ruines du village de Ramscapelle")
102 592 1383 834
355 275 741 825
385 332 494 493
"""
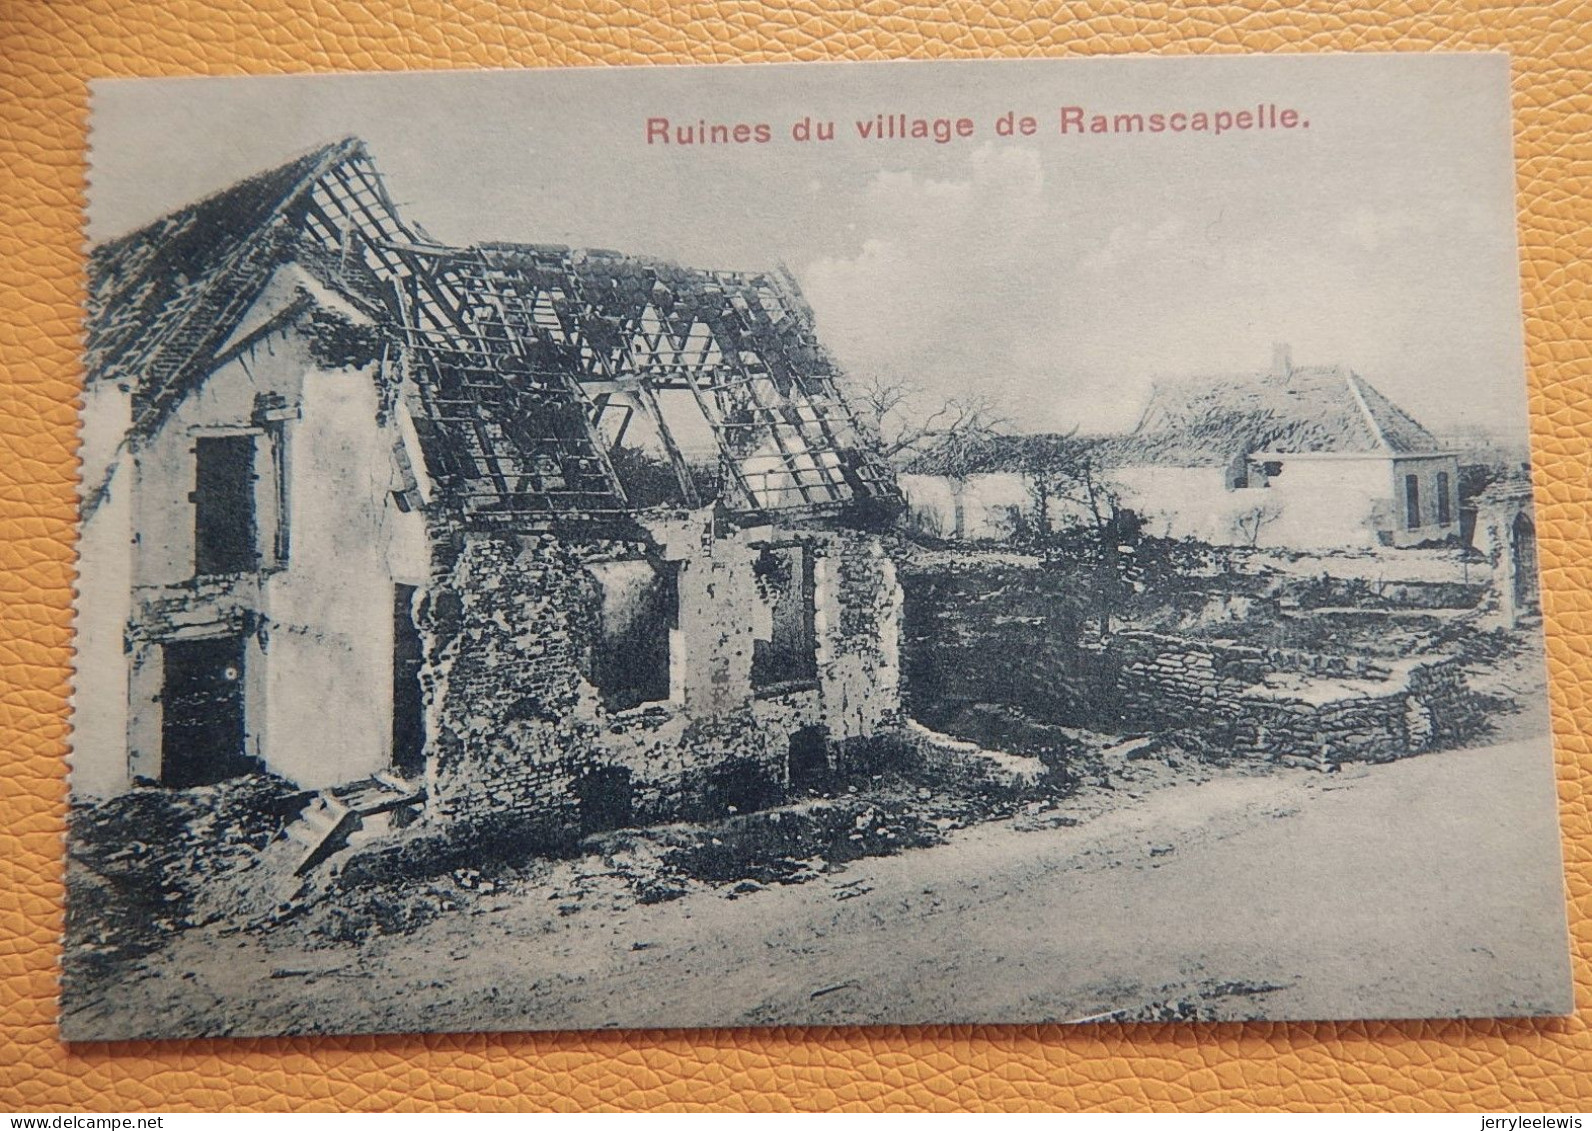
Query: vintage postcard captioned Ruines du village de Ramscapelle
60 54 1571 1040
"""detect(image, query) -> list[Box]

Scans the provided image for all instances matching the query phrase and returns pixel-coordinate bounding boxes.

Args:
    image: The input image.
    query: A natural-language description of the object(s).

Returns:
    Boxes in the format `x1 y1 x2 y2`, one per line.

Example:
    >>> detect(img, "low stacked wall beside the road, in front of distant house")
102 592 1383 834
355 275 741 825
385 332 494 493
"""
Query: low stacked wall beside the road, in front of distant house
1102 632 1482 765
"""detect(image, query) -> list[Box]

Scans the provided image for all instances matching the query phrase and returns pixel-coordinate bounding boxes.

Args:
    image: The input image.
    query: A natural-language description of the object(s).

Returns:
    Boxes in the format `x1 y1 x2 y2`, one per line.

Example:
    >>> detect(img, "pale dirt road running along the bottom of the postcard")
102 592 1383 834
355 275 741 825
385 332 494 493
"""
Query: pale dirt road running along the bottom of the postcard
70 729 1571 1039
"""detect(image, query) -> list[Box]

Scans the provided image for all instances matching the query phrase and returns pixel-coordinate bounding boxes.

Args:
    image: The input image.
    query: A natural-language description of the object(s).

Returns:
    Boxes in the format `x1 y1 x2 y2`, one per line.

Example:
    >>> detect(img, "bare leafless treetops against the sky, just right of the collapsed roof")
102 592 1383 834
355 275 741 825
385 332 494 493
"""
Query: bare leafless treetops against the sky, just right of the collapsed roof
847 373 1011 467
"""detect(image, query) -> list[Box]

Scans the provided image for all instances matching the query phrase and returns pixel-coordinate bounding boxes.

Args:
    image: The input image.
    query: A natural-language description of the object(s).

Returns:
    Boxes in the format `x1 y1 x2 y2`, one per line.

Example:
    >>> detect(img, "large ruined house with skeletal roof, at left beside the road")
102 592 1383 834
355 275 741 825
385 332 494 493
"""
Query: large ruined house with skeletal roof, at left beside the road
72 139 899 853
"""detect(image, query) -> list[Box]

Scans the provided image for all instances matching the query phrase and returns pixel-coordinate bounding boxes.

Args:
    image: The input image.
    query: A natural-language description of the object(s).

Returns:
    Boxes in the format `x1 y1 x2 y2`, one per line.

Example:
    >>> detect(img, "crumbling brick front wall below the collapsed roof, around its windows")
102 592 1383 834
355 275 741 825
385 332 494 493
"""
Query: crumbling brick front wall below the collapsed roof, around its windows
416 530 901 839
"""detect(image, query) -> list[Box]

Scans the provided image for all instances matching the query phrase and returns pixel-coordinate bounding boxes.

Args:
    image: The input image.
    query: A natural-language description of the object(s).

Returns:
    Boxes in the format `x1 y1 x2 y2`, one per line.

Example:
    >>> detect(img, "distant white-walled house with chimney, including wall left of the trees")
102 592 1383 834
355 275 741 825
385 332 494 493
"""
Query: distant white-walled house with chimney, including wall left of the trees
901 346 1460 550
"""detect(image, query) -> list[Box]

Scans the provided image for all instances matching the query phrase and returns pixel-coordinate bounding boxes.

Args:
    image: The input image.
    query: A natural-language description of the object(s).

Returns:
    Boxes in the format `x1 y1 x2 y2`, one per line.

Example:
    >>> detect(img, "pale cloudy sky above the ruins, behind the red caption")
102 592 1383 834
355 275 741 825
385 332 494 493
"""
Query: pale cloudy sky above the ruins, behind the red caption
89 54 1525 430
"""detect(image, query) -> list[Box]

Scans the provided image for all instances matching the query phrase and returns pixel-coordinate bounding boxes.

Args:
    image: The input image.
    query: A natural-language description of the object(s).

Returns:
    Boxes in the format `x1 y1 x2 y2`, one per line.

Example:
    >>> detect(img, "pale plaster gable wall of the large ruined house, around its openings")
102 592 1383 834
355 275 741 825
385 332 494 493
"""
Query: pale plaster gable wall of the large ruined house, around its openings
106 280 430 792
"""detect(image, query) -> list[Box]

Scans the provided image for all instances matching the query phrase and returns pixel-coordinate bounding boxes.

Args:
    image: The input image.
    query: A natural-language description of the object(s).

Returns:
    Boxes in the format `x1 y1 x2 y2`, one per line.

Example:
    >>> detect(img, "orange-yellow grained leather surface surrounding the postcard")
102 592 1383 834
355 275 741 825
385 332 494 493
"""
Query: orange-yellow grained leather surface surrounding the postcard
0 0 1592 1112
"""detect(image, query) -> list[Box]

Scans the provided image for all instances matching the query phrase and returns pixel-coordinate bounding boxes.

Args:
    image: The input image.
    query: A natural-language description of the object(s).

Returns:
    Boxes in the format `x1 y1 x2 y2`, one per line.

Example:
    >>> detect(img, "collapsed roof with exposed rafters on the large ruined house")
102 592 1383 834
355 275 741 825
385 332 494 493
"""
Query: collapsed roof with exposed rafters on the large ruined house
88 139 899 526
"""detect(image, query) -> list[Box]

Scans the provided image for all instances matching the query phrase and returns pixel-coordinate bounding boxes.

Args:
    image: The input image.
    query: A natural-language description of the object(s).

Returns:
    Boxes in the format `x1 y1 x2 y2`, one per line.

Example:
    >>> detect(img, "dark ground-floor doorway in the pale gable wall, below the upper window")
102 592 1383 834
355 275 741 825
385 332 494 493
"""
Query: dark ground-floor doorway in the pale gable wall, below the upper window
161 636 259 789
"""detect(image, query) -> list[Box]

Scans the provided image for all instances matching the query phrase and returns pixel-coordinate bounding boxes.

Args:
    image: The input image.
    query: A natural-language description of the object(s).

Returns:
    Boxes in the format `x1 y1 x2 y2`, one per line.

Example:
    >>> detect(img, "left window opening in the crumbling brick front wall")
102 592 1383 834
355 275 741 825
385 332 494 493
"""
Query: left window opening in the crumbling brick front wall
591 561 680 710
